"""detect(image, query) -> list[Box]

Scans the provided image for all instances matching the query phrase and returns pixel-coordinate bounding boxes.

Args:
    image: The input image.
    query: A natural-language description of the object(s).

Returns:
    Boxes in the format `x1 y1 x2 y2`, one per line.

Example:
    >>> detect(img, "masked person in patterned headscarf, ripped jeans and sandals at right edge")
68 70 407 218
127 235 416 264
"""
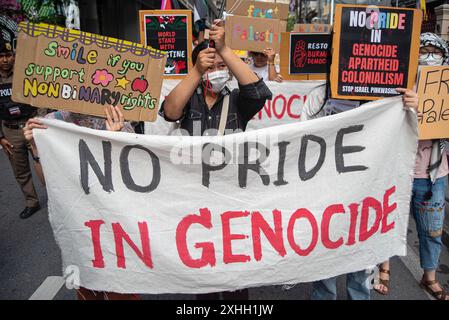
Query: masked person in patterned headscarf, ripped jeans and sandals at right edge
374 32 449 300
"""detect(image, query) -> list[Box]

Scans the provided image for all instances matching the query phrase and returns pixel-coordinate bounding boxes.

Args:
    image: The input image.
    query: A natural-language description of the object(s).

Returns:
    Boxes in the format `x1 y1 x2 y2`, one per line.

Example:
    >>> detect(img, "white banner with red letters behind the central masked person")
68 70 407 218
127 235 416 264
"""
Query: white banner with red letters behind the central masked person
145 80 324 135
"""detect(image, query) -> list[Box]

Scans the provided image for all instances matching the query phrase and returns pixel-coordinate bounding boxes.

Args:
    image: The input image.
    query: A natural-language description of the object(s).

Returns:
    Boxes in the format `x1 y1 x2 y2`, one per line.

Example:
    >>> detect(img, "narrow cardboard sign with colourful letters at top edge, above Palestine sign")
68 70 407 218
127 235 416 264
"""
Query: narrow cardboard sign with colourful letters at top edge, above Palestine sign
226 0 289 20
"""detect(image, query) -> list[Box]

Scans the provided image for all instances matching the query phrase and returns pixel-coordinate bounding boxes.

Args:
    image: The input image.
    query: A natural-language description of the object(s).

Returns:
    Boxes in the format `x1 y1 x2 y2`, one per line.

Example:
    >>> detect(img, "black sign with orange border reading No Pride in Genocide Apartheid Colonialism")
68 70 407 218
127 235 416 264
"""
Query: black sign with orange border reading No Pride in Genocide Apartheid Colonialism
331 5 422 100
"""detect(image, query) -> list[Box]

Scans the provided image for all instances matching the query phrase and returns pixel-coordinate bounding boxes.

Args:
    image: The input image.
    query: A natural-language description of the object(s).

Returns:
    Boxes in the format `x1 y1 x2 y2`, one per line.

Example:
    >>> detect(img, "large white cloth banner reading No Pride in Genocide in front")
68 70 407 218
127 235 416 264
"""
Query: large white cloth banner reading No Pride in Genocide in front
34 97 418 294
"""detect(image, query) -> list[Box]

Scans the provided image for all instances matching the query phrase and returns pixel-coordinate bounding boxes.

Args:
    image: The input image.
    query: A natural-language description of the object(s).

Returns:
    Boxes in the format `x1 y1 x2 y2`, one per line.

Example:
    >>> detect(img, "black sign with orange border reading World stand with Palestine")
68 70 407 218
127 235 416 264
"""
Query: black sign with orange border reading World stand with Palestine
139 10 192 78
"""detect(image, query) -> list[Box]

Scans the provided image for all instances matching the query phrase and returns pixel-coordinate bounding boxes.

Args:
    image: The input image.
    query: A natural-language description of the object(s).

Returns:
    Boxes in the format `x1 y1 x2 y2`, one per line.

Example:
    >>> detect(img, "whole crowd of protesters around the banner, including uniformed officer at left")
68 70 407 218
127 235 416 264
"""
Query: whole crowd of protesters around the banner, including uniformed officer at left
0 21 449 300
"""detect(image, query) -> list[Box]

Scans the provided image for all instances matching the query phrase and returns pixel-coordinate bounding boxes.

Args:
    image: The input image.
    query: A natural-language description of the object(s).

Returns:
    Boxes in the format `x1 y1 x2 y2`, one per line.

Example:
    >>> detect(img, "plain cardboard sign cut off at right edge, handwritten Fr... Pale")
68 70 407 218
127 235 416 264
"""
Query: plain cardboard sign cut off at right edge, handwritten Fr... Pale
418 66 449 140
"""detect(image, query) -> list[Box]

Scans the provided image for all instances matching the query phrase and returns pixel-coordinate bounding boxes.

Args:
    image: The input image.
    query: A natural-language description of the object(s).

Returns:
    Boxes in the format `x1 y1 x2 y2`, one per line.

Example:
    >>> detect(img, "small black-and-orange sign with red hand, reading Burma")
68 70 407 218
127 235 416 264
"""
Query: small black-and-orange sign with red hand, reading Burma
280 32 331 80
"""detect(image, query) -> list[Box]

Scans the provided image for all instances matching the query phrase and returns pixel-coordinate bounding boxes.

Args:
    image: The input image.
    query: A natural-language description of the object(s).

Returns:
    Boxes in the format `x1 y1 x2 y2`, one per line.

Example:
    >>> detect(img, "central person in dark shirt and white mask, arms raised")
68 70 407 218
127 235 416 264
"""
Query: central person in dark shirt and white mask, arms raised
160 20 272 136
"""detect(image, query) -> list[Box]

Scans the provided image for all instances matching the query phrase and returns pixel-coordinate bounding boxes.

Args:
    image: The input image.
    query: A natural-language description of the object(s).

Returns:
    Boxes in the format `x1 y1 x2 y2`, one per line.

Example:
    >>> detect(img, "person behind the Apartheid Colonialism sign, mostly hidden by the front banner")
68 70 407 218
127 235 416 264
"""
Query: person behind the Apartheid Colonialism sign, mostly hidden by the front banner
300 74 418 300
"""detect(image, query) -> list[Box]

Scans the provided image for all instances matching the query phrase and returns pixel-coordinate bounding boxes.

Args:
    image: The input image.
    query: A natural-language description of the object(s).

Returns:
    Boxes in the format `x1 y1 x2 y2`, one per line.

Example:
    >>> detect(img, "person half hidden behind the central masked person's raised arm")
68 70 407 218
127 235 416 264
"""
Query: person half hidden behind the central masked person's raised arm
249 48 283 82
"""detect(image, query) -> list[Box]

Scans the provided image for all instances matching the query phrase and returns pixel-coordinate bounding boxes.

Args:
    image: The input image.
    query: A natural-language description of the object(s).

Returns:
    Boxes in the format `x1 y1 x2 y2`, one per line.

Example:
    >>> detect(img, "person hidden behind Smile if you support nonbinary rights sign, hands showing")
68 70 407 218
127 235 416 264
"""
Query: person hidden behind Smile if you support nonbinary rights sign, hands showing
23 106 135 300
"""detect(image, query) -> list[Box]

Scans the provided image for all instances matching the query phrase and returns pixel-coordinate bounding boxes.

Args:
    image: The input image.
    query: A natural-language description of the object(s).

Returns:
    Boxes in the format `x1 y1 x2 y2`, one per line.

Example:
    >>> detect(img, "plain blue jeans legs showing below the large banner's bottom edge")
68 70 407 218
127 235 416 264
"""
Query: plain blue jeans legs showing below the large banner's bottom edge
311 270 370 300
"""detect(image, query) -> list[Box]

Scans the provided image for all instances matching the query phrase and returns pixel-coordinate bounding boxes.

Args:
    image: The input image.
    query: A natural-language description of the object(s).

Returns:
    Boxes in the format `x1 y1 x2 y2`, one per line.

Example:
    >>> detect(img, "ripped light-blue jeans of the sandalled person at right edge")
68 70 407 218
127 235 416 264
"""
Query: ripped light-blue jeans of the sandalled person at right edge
411 177 447 271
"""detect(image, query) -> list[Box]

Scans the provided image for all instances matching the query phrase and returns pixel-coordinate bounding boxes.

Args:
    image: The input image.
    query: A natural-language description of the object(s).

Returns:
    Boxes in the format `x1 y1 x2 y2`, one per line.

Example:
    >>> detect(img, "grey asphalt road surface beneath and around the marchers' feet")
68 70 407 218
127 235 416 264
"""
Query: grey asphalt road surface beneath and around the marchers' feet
0 150 449 300
